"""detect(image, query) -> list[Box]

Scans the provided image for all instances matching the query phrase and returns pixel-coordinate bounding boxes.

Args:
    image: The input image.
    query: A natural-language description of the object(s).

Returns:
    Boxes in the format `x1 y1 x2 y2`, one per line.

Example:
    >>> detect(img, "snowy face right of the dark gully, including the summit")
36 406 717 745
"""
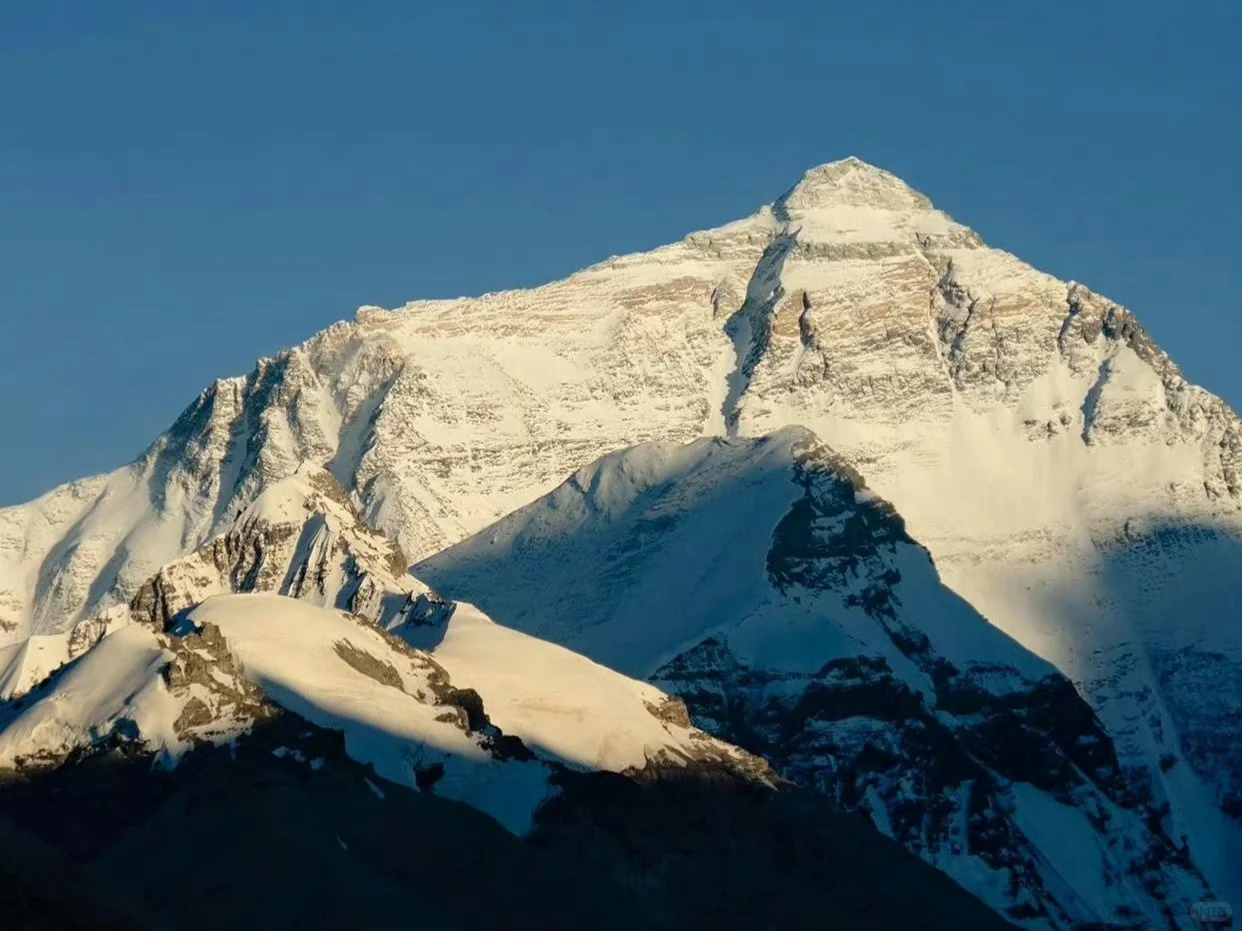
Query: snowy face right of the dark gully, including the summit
720 163 1242 895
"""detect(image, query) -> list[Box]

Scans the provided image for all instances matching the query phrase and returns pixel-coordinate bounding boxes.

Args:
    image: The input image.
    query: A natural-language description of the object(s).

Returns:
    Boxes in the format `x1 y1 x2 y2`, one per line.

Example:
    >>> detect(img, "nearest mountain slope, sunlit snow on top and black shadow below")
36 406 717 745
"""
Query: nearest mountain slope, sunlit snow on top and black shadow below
0 561 1007 931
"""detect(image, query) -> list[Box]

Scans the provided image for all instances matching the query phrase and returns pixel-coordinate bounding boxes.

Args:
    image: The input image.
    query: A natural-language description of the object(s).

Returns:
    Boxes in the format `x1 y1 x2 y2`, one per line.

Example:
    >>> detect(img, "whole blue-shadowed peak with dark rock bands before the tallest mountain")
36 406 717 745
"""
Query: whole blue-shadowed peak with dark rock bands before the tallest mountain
415 428 1206 929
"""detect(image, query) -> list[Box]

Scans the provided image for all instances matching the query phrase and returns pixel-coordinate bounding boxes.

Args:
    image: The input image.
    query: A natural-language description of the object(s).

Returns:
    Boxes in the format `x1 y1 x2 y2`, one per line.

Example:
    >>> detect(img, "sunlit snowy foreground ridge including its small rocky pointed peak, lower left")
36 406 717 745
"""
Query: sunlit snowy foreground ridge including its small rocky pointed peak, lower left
0 456 770 833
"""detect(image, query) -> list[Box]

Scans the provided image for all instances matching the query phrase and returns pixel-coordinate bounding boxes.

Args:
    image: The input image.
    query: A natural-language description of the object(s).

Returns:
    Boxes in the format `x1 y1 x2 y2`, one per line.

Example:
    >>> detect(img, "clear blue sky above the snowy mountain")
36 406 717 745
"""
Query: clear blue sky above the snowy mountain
0 0 1242 504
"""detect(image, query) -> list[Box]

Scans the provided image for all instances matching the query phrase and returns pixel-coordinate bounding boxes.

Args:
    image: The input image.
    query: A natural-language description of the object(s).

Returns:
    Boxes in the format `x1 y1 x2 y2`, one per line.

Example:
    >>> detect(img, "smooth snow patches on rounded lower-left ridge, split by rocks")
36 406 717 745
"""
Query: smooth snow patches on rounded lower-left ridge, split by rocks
144 593 739 834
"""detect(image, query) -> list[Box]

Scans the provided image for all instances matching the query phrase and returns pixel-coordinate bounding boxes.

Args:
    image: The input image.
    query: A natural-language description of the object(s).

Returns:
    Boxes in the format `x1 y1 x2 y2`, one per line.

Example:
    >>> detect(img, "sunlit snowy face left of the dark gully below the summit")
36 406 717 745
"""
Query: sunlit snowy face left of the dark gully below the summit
0 212 774 644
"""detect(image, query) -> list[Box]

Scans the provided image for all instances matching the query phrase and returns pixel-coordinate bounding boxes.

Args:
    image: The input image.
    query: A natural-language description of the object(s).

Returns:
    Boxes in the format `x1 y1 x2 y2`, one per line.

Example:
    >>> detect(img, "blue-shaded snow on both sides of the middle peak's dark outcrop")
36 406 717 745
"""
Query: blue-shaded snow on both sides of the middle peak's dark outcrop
415 428 1056 696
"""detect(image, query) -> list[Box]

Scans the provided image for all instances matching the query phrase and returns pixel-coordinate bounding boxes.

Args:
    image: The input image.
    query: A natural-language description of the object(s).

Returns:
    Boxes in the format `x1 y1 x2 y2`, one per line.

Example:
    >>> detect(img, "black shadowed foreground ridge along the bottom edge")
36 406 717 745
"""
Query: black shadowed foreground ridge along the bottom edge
0 714 1011 931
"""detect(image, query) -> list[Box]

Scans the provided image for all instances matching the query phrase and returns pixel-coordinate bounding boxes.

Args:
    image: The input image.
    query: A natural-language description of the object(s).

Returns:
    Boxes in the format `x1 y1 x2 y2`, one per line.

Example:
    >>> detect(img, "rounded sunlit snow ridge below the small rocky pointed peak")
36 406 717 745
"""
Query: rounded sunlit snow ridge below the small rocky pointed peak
0 595 773 834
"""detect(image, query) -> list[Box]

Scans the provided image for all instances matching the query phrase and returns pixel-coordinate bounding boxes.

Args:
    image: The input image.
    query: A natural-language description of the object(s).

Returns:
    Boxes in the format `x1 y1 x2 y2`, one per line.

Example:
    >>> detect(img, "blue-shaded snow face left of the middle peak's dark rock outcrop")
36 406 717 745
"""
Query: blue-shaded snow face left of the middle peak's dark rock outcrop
415 431 802 678
